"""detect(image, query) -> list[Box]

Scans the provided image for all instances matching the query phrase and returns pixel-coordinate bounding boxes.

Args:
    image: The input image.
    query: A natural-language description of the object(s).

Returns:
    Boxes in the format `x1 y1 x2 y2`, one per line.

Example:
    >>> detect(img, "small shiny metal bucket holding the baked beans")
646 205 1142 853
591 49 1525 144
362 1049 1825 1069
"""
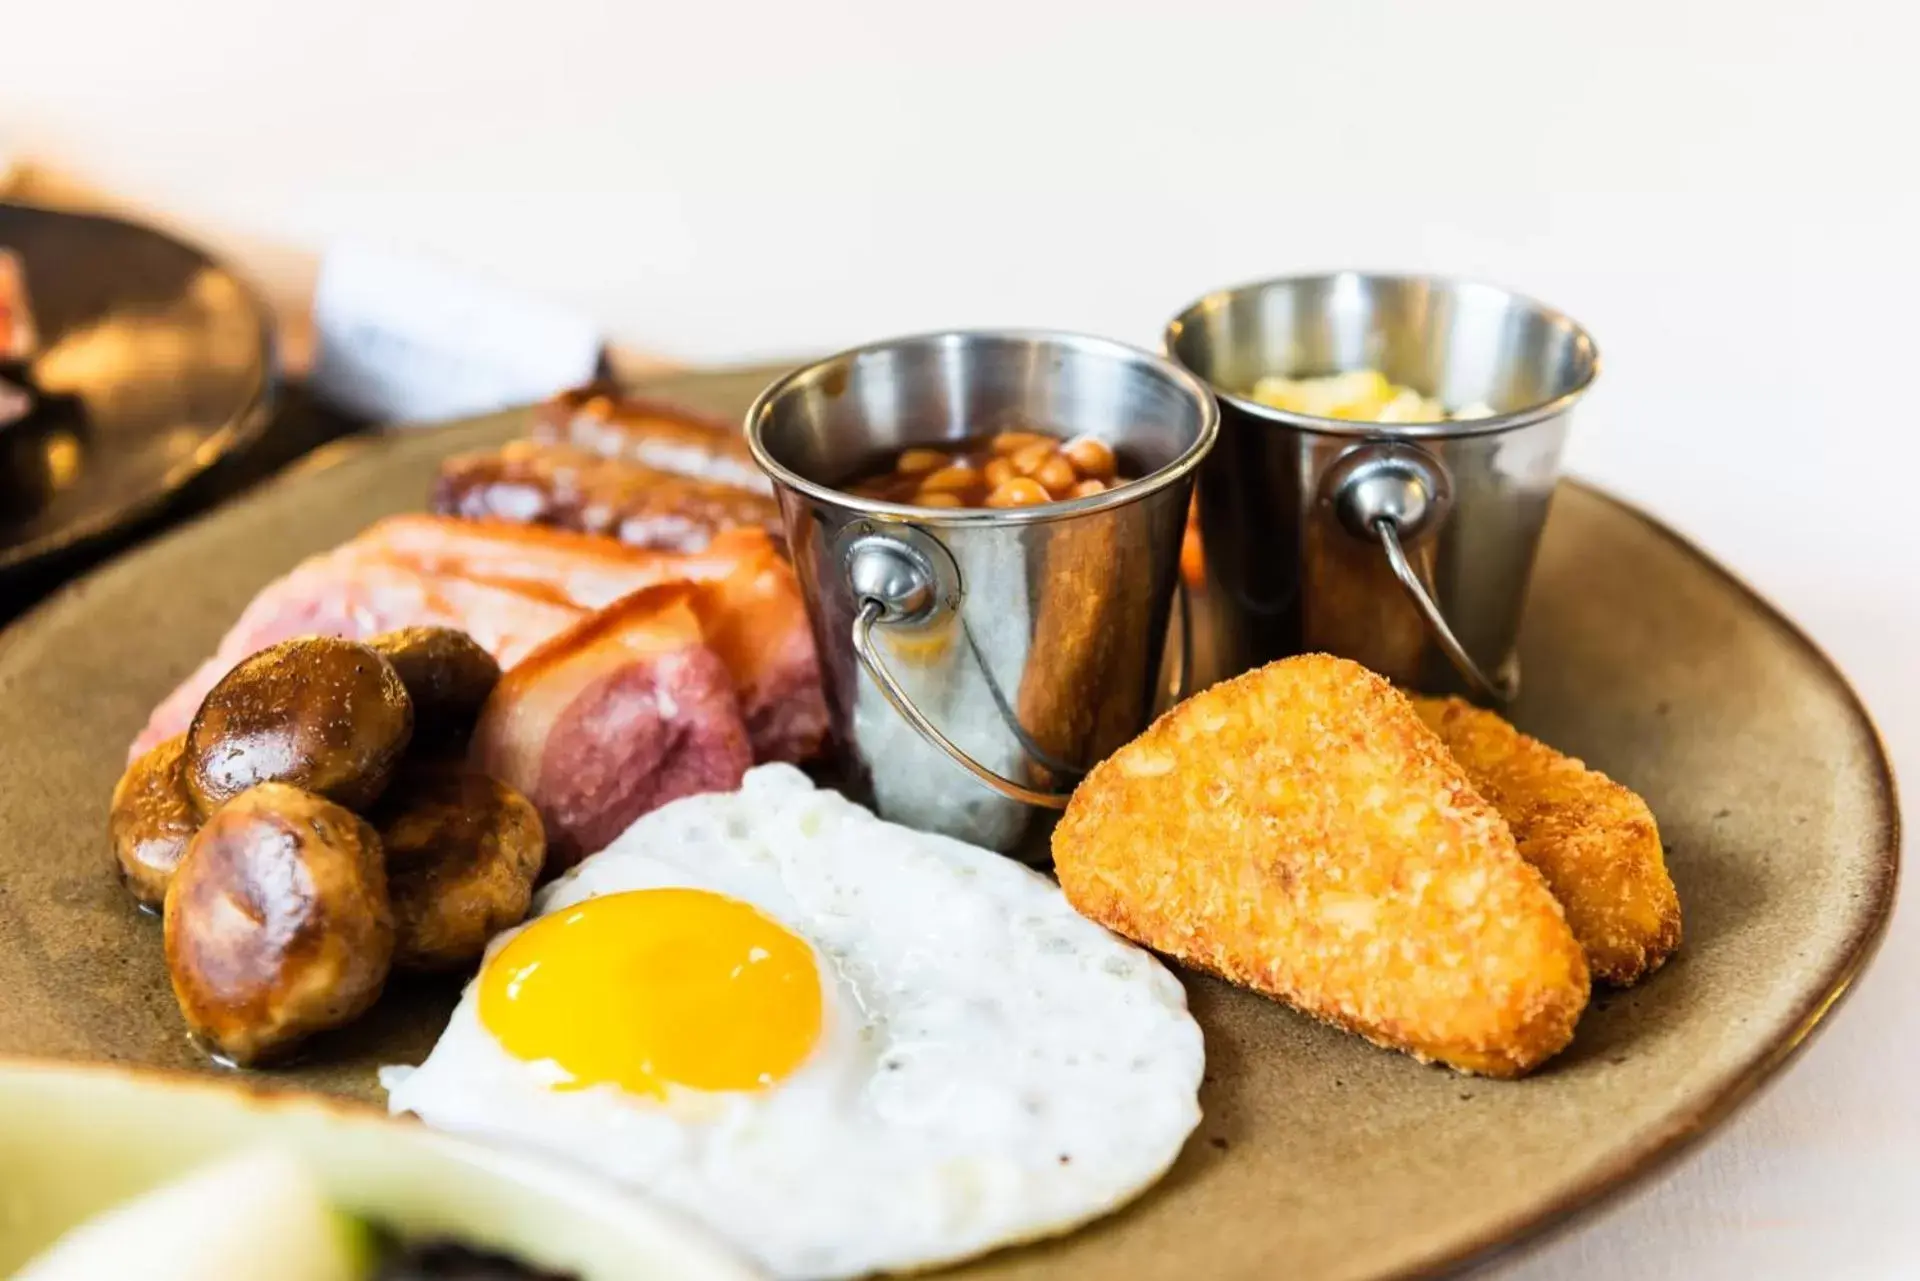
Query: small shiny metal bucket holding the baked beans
747 332 1219 853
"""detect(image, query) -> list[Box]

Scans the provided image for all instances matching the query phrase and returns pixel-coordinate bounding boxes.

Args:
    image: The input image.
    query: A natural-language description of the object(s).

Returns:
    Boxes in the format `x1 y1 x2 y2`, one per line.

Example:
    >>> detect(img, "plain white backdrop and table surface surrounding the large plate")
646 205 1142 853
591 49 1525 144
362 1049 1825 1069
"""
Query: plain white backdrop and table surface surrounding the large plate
0 0 1920 1281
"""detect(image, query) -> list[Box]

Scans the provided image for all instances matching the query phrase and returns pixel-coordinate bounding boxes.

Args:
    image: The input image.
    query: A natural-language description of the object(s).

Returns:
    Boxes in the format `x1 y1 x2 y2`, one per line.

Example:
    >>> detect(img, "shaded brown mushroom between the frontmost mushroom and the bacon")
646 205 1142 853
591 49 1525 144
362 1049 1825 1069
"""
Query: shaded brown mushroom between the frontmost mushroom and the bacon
372 764 547 970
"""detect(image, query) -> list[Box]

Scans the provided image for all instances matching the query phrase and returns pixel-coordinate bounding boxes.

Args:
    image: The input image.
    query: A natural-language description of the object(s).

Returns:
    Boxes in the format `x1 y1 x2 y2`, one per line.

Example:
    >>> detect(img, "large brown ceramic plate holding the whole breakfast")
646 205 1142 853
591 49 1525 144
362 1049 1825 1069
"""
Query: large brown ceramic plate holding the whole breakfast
0 371 1897 1281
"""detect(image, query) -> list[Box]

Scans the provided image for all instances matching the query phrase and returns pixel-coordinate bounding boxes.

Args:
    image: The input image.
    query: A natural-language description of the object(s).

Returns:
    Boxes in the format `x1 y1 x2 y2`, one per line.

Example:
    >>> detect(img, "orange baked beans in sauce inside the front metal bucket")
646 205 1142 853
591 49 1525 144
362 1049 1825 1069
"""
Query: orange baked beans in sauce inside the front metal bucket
849 430 1135 507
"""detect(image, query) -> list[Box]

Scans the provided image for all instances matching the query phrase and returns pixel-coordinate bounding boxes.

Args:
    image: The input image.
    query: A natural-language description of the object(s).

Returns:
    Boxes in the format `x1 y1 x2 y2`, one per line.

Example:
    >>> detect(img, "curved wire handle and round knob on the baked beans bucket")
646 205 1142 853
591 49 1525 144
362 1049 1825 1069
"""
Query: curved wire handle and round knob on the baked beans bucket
845 530 1192 810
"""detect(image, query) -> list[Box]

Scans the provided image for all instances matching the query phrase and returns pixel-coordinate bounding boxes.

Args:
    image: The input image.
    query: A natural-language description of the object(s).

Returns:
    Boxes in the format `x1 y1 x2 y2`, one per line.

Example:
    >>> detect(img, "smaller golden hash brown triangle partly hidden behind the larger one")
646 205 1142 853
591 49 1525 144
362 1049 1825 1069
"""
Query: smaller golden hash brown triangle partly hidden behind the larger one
1413 697 1680 985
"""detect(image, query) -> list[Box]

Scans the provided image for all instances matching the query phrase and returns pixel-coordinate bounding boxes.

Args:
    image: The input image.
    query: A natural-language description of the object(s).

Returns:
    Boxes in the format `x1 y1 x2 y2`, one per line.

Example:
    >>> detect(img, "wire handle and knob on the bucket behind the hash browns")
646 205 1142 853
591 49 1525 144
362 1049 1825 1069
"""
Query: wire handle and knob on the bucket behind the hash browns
1327 444 1521 703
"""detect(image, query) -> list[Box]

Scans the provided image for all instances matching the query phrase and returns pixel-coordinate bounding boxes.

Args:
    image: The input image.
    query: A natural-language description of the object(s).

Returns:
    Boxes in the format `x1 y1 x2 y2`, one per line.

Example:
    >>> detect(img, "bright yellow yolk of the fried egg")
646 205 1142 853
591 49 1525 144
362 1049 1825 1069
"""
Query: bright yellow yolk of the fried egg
480 889 820 1099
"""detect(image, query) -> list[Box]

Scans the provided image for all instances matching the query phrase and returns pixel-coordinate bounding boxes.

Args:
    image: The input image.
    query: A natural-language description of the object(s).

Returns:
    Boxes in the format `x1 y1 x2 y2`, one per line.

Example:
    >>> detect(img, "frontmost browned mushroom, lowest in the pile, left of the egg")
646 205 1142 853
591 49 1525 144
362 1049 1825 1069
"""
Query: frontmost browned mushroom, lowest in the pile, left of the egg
165 784 394 1066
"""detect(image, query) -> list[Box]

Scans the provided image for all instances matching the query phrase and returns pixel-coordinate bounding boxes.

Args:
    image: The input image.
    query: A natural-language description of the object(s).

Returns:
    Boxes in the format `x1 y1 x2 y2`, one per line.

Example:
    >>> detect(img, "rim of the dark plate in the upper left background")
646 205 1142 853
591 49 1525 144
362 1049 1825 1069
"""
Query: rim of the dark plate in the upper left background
0 200 280 572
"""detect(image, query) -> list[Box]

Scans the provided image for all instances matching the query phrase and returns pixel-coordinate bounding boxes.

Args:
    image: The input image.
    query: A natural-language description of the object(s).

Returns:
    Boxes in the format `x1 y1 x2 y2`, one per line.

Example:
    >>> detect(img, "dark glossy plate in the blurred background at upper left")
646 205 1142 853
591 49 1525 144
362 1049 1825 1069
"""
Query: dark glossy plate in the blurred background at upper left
0 202 273 595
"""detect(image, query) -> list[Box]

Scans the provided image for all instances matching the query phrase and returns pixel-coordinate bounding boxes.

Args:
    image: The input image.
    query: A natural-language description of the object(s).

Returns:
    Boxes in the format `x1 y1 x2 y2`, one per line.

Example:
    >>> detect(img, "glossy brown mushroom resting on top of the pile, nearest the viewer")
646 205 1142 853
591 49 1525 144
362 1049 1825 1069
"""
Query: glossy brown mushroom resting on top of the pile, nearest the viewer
184 636 413 814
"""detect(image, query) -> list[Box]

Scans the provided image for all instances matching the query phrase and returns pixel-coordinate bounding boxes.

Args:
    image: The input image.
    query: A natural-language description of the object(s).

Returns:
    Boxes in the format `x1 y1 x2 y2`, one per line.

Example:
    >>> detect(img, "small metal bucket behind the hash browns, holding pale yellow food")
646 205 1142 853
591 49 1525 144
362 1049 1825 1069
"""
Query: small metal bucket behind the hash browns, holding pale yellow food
1165 273 1599 701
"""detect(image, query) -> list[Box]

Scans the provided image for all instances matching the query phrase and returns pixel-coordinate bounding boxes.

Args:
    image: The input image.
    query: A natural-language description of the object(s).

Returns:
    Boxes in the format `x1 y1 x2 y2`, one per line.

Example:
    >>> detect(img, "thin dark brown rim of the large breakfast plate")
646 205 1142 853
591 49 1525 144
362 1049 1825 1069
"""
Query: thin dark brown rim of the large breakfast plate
0 391 1901 1281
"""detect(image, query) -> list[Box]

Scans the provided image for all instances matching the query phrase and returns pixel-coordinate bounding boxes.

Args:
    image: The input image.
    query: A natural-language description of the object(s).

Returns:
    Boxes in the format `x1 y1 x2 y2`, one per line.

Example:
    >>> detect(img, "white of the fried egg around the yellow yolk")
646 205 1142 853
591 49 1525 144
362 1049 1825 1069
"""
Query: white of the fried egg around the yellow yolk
382 764 1204 1277
